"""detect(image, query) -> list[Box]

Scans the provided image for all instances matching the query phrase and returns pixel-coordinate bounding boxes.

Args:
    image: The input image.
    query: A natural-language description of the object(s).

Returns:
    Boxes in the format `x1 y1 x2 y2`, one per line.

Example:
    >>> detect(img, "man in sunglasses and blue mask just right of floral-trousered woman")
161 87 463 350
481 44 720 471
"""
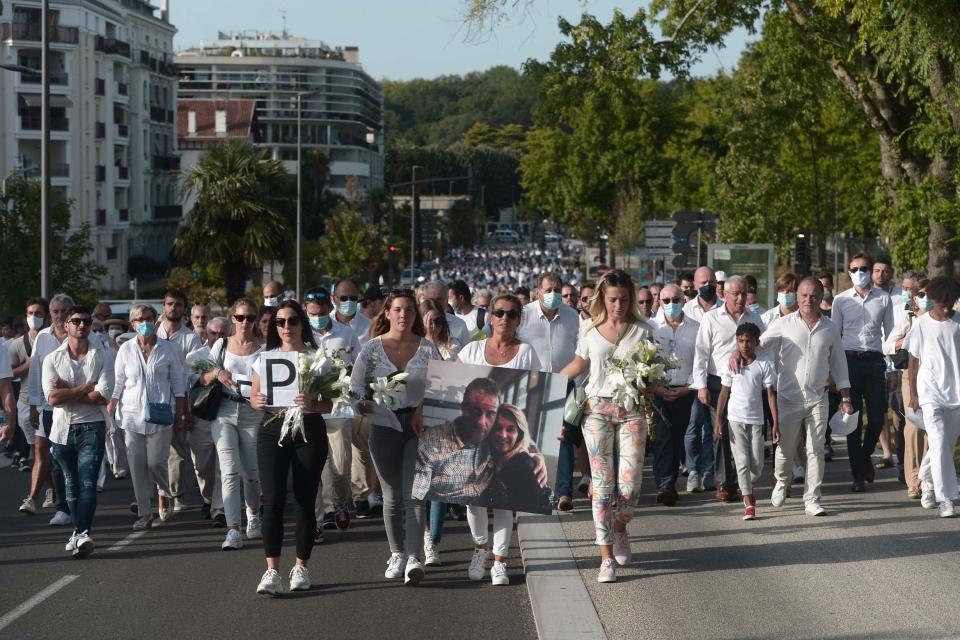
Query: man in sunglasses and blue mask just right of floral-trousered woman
651 284 700 507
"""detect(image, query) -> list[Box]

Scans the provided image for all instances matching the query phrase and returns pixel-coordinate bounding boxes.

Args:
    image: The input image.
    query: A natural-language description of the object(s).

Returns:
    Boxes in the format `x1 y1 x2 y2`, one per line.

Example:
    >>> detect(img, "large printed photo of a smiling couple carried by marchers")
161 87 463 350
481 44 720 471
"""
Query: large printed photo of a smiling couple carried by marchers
413 361 567 514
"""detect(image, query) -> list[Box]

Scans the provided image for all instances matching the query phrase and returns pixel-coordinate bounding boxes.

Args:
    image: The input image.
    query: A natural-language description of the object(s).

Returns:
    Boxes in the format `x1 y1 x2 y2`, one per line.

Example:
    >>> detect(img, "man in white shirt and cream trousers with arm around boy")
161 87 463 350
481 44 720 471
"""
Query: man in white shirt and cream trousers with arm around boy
758 278 854 516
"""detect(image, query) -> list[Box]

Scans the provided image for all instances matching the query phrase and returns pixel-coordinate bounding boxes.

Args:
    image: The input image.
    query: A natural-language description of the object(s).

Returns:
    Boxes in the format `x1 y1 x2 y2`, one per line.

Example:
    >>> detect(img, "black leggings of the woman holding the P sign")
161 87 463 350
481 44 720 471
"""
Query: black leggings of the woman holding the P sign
257 413 328 560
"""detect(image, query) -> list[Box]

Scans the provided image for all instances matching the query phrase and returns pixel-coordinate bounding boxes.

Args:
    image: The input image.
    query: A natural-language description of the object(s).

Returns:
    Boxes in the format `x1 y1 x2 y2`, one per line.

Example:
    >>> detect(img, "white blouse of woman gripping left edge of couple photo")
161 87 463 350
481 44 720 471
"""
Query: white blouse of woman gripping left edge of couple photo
350 336 443 431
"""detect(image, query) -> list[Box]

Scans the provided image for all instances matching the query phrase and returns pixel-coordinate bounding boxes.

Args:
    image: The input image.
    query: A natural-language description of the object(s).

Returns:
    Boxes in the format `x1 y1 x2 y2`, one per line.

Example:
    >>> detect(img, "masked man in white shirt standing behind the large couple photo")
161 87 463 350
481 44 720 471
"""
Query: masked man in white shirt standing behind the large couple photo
517 272 580 511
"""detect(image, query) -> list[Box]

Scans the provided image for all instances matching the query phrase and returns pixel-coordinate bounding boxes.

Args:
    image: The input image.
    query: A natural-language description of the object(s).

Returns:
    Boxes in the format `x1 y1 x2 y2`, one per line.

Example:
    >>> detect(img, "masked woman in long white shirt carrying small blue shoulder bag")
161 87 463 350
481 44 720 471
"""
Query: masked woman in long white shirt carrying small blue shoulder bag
107 304 187 530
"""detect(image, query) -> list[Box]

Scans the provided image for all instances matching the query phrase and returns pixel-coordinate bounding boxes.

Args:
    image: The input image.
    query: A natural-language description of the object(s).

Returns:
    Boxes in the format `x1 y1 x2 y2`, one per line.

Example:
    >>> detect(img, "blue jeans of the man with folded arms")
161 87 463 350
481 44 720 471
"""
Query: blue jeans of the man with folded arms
50 420 107 532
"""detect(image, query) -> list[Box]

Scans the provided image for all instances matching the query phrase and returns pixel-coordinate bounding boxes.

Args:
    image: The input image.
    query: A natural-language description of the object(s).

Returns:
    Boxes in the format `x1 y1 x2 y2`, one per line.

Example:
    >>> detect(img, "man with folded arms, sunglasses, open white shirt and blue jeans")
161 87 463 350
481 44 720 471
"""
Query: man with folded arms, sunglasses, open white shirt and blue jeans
43 306 113 558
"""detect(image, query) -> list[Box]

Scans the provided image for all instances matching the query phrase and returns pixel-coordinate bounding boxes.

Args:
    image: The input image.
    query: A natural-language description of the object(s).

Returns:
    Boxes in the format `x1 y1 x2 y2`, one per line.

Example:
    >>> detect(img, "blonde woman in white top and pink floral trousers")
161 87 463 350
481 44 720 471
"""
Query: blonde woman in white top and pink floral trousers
560 269 651 582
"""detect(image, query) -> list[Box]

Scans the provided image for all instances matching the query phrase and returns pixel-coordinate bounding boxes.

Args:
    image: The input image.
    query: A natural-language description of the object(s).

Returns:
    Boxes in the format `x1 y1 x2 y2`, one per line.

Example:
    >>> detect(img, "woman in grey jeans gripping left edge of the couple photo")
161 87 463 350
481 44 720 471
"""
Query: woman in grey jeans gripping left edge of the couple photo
350 289 441 585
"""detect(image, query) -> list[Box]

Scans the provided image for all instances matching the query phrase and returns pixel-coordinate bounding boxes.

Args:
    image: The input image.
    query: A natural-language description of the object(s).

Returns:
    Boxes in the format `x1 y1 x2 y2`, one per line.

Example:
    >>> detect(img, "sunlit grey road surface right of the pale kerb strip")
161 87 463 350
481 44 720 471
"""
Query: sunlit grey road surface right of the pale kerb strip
561 446 960 640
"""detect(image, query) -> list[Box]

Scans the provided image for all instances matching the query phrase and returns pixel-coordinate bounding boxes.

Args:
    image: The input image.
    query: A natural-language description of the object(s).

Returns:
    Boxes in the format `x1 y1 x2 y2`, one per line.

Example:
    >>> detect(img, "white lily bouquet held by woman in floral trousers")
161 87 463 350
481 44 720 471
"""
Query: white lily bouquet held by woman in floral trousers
606 340 680 440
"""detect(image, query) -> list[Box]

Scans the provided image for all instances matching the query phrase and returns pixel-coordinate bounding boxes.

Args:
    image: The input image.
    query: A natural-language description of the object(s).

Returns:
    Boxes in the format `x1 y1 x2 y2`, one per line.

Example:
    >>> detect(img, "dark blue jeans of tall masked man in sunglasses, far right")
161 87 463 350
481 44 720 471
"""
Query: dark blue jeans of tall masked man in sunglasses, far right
847 353 887 481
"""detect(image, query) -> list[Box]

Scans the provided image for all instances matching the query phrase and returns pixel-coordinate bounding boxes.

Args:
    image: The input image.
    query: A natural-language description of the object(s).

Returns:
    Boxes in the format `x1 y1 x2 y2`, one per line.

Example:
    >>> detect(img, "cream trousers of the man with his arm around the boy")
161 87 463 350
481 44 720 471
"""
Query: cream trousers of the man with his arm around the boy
773 394 828 502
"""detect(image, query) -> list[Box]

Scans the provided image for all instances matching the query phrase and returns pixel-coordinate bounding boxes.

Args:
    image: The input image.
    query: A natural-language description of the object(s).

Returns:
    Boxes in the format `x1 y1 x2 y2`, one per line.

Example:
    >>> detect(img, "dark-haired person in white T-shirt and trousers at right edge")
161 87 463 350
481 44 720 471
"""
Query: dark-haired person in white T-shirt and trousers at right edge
907 276 960 518
